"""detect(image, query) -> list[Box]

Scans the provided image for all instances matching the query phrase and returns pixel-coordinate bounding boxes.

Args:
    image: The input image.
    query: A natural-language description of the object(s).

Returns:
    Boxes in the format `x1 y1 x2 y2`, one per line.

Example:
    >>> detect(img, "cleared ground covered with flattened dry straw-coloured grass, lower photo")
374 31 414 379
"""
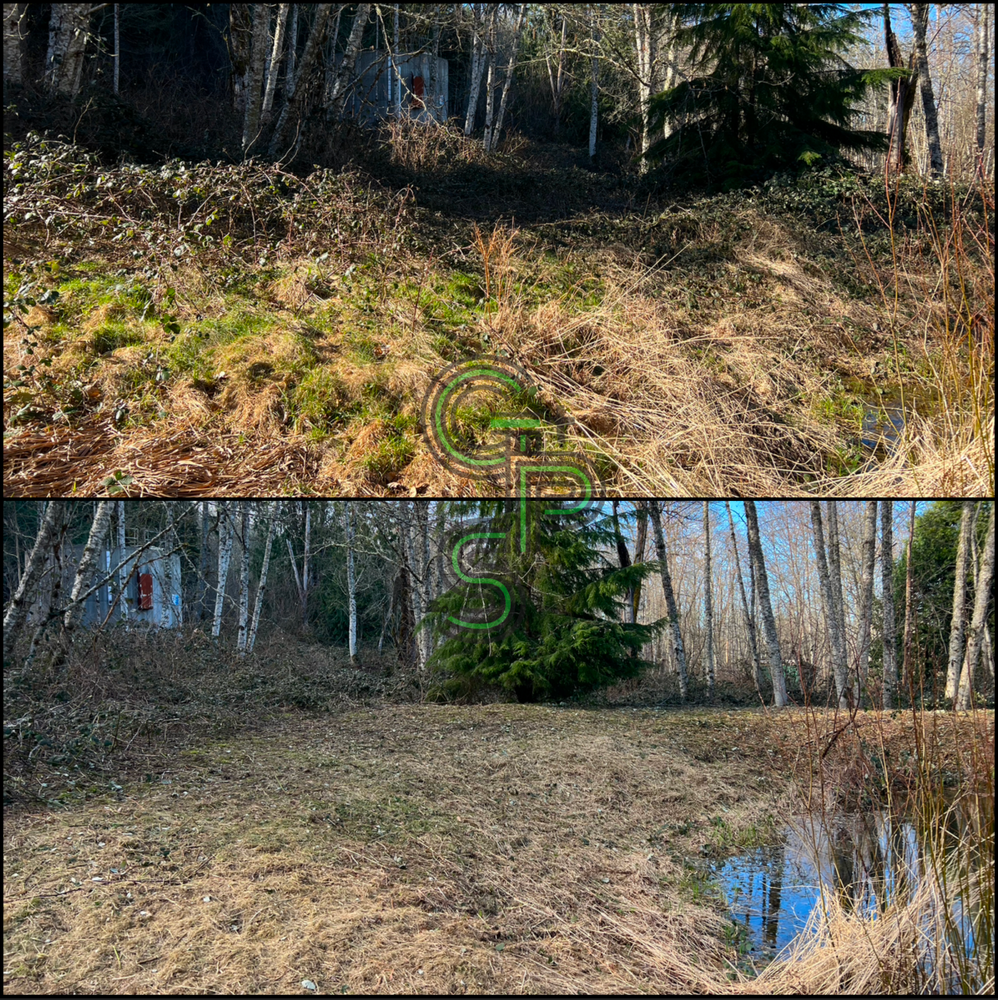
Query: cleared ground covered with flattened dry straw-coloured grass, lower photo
4 704 993 994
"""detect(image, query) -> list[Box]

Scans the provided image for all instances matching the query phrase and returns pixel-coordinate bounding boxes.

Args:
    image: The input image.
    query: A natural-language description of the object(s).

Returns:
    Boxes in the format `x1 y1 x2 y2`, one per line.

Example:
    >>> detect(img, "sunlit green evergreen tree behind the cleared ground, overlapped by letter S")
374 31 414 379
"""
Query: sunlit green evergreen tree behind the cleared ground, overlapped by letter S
430 500 666 701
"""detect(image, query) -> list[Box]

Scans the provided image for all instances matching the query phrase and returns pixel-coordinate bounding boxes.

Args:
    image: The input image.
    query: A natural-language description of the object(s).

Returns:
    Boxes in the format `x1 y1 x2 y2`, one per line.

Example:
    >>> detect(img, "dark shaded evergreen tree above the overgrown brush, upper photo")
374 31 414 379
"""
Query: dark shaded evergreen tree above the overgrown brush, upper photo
646 3 908 189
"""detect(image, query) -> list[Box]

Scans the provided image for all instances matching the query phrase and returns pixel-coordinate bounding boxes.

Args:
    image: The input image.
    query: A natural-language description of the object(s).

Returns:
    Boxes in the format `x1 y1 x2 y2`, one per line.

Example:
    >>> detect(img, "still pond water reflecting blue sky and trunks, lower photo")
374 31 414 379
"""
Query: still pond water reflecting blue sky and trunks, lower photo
715 799 994 984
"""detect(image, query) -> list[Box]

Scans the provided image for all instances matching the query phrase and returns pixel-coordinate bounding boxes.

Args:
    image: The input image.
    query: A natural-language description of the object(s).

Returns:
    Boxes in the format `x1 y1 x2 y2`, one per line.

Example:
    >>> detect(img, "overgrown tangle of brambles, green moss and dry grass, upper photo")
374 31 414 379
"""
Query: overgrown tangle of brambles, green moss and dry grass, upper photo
4 127 994 496
